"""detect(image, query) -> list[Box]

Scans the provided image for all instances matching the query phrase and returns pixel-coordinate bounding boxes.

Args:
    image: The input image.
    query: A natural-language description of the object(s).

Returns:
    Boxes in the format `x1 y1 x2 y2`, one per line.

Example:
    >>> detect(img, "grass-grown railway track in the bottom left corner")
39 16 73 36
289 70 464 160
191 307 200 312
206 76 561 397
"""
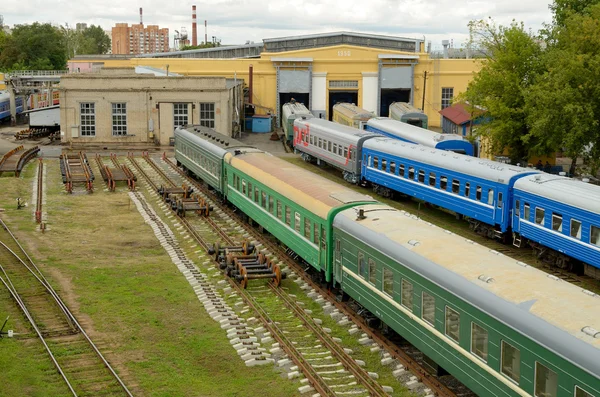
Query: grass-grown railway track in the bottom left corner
0 219 132 396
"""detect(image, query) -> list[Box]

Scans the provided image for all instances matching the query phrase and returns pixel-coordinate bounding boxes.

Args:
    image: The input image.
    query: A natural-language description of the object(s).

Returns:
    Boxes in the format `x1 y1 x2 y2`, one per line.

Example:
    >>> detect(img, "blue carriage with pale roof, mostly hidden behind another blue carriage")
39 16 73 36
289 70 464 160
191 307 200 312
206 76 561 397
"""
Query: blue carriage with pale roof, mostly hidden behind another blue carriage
366 117 473 156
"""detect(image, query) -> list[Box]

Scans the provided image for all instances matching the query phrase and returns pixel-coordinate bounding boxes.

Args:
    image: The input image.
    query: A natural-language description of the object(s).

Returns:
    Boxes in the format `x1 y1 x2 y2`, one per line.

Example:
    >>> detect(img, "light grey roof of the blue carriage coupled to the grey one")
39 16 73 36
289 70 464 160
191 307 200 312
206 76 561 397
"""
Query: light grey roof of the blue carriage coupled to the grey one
363 138 539 184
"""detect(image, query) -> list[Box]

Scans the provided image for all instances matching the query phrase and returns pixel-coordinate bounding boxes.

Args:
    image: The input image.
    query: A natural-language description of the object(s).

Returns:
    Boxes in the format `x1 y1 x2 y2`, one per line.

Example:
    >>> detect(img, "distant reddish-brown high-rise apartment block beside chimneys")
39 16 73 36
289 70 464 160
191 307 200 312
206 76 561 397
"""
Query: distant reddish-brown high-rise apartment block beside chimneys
112 23 169 55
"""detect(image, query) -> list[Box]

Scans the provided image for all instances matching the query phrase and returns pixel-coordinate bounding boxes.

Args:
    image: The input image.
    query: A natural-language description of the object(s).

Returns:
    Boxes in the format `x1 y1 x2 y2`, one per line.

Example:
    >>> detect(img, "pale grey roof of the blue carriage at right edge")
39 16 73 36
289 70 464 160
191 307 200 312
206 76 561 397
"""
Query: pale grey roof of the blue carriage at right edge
515 172 600 214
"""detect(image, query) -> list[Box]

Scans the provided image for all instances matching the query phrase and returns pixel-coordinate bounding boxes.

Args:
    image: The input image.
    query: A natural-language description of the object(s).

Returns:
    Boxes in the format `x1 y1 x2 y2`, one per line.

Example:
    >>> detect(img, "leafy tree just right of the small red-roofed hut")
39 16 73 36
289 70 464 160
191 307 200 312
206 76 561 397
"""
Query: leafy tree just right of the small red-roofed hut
458 20 543 162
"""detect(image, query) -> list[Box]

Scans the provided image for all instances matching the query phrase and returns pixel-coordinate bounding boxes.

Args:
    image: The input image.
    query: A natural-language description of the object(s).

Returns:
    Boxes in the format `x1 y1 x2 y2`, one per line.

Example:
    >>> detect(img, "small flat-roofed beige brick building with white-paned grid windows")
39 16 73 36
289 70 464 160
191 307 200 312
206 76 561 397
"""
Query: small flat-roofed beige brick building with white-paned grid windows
60 68 244 147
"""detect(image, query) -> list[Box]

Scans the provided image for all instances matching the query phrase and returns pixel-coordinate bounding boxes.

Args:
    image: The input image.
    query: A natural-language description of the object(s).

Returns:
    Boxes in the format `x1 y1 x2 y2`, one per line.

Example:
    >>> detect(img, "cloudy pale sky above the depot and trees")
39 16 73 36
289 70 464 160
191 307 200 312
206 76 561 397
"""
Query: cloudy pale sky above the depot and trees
0 0 552 50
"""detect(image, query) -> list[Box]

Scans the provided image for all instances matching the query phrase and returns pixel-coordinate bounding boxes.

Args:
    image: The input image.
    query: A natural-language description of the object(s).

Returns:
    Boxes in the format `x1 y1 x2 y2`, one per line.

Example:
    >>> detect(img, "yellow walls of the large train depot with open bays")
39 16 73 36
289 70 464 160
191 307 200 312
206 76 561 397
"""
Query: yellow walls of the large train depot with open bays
70 45 480 127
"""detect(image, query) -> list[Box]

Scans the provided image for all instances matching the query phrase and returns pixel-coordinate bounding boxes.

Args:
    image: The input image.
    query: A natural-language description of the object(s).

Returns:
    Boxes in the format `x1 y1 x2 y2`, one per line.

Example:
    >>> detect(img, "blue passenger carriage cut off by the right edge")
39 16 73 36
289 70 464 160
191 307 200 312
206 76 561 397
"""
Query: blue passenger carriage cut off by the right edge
513 173 600 275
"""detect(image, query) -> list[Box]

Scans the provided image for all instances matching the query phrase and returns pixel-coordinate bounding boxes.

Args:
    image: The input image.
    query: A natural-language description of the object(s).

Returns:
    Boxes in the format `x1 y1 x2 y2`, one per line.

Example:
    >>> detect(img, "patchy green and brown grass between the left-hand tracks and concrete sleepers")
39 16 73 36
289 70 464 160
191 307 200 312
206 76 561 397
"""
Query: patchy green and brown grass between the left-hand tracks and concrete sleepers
0 160 299 396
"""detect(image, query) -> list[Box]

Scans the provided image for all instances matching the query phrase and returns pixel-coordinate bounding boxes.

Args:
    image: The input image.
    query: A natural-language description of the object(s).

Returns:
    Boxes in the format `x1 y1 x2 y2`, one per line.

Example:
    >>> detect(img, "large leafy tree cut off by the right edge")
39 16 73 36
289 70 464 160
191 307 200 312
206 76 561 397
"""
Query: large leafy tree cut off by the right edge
525 4 600 174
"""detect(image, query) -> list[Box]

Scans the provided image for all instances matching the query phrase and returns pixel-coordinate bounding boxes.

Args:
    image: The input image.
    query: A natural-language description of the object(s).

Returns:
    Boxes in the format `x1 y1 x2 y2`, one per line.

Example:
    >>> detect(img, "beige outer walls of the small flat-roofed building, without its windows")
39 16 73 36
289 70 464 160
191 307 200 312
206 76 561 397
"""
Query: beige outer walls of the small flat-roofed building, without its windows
60 69 243 146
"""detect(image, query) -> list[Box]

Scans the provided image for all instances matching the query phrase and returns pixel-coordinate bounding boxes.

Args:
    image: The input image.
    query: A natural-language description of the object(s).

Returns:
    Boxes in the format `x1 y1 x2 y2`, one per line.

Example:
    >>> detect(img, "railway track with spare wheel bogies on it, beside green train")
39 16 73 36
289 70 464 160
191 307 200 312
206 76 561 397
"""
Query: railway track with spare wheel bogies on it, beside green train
129 156 390 396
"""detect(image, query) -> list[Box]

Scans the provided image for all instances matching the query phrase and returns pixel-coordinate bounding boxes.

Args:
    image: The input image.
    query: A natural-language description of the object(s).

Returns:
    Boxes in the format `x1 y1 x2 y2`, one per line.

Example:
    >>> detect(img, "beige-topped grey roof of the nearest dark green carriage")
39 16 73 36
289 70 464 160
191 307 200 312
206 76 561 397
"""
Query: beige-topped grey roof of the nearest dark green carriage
334 204 600 376
